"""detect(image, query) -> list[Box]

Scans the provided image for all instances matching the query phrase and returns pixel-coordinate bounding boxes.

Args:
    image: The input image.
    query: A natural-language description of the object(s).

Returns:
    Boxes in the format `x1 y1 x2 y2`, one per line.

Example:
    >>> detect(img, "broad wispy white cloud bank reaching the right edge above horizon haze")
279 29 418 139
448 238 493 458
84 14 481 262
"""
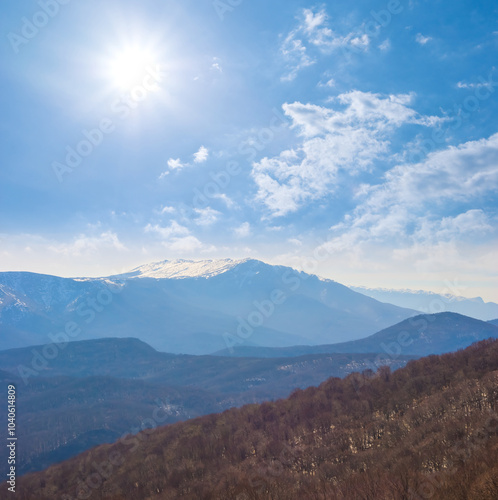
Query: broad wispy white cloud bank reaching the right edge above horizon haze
318 134 498 252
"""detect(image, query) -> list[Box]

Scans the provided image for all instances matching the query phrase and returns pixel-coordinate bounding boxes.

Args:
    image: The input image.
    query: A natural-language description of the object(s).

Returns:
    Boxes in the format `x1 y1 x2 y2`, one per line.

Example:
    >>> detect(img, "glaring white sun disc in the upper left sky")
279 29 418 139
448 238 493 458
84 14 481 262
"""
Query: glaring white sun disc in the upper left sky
110 47 155 90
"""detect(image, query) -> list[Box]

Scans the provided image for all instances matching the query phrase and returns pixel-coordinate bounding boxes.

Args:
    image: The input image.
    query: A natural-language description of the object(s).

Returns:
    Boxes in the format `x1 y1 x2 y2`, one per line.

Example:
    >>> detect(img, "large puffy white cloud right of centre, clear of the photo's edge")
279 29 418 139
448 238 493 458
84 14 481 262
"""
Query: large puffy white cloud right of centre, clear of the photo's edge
252 91 438 216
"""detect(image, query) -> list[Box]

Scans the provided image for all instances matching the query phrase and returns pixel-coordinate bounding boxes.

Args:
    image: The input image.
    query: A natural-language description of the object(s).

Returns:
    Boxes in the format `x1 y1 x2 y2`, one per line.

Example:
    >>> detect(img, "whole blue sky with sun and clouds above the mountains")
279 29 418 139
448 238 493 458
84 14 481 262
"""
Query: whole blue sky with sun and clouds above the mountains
0 0 498 301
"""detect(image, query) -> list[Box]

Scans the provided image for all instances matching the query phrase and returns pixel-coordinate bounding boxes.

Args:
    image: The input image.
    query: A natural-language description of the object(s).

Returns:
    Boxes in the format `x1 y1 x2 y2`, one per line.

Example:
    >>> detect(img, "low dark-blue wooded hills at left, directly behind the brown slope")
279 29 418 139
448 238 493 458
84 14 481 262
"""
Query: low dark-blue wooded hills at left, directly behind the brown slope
0 339 413 475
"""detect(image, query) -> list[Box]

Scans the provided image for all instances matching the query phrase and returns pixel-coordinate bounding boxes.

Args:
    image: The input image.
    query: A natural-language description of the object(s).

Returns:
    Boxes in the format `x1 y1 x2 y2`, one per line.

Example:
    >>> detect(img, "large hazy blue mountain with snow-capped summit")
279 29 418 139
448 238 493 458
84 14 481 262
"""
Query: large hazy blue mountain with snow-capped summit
0 259 416 354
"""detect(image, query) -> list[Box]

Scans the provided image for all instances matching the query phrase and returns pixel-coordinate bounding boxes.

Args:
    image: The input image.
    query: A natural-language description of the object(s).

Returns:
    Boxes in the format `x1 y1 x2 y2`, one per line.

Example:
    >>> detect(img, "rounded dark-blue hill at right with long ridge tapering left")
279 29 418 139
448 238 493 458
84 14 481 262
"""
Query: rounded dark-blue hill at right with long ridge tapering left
215 313 498 358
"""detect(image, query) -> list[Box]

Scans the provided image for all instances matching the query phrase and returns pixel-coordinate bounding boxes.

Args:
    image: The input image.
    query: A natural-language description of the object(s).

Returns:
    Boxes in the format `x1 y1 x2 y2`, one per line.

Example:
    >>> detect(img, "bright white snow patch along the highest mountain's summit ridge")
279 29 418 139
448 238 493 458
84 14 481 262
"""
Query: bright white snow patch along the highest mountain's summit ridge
120 259 250 279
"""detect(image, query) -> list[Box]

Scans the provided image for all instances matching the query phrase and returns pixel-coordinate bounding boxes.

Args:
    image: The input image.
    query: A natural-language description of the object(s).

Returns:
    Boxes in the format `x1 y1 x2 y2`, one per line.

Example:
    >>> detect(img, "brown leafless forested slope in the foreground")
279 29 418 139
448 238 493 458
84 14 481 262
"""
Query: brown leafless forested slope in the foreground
12 340 498 500
